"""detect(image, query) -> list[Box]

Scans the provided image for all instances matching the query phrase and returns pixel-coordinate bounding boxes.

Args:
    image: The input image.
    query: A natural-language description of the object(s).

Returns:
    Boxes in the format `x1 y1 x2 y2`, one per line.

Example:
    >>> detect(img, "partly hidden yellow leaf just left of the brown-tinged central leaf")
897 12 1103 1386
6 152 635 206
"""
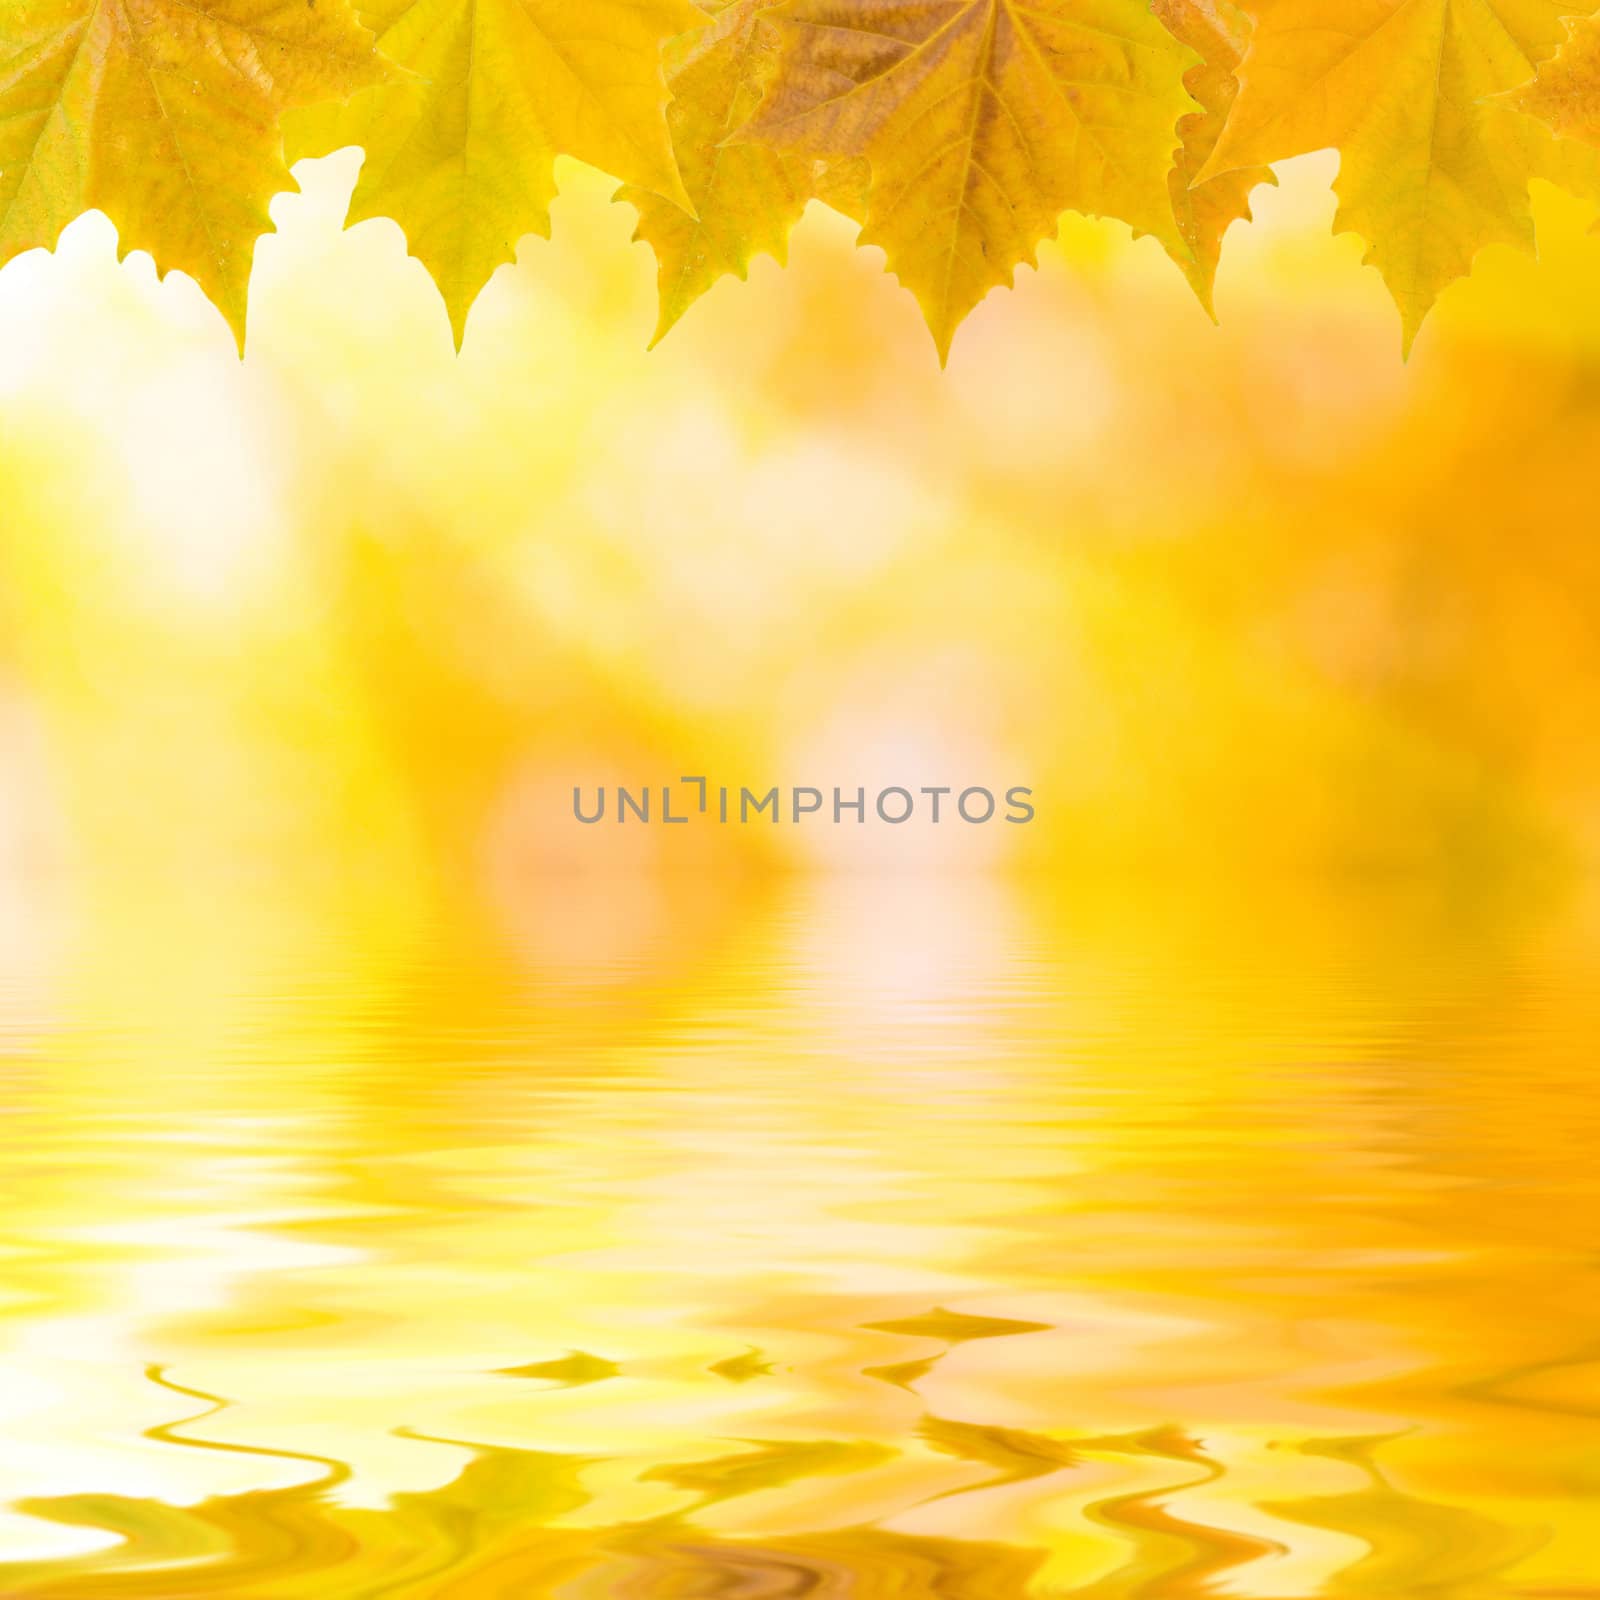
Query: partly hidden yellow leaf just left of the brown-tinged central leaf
616 0 814 344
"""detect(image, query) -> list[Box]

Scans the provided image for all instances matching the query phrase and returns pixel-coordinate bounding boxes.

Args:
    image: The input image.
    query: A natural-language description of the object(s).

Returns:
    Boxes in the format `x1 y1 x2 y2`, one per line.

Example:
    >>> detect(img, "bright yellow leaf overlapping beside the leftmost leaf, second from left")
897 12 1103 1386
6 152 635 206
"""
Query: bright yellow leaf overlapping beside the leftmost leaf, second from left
286 0 706 346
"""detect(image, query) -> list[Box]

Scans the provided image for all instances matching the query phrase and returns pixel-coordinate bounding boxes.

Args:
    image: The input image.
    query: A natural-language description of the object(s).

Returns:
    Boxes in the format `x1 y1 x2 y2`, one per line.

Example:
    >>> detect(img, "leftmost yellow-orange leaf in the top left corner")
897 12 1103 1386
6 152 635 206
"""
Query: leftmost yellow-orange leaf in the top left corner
0 0 384 347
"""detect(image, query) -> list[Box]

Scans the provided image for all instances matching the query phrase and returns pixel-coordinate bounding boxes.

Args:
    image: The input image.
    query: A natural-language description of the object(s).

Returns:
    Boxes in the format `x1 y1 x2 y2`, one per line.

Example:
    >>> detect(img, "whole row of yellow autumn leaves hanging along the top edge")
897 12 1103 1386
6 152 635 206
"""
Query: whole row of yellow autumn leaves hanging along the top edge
9 0 1600 358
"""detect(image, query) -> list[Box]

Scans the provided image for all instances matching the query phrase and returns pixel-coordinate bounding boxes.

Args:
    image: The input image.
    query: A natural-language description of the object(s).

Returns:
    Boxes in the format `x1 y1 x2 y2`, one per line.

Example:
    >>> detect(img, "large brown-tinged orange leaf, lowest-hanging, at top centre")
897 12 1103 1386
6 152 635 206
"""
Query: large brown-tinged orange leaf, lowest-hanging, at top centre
741 0 1195 362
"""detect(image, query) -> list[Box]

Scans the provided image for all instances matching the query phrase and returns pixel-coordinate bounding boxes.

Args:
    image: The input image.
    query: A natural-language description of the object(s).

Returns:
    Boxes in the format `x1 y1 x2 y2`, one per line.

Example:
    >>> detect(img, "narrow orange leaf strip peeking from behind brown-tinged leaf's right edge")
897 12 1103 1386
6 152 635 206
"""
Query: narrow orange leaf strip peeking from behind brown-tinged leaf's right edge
1154 0 1277 317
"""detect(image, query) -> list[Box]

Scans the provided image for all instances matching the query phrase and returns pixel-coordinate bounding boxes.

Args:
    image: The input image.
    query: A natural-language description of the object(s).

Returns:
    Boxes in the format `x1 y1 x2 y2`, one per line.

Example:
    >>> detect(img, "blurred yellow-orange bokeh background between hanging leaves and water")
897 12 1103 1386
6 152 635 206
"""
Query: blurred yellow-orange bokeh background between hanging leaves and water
0 152 1600 934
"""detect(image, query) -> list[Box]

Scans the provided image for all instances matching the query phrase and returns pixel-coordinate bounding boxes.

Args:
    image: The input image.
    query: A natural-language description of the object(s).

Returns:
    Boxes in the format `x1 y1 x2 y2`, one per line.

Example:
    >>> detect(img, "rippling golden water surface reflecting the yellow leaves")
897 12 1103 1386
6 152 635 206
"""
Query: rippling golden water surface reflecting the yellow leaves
0 877 1600 1600
